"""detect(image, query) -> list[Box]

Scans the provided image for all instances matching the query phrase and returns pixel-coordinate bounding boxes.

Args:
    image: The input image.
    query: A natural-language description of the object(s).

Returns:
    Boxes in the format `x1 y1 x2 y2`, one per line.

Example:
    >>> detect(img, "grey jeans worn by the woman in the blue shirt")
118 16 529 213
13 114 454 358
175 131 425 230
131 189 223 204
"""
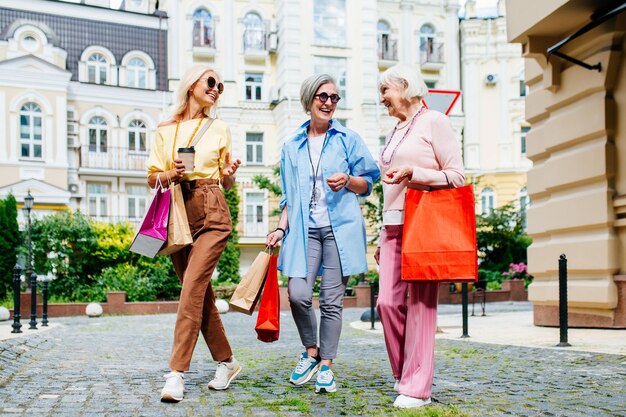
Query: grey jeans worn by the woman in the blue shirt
289 226 348 359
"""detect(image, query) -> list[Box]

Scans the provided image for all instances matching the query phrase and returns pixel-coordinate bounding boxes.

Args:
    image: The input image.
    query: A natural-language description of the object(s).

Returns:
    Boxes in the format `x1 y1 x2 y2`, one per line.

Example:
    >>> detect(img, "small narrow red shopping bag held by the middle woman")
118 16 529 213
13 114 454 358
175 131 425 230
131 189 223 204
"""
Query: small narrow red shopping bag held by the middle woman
254 255 280 342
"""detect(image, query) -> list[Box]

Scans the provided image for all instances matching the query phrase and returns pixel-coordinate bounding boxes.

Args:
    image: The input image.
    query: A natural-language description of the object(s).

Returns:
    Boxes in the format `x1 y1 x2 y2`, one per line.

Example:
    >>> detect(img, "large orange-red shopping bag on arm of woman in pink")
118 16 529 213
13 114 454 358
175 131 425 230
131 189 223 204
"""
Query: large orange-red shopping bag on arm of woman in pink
402 185 478 282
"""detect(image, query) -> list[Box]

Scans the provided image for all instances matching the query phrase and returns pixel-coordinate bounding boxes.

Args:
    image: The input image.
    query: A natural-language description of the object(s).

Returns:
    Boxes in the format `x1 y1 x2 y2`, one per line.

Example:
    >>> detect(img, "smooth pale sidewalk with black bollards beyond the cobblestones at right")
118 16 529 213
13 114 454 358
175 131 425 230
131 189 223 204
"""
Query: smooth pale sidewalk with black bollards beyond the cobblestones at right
351 302 626 355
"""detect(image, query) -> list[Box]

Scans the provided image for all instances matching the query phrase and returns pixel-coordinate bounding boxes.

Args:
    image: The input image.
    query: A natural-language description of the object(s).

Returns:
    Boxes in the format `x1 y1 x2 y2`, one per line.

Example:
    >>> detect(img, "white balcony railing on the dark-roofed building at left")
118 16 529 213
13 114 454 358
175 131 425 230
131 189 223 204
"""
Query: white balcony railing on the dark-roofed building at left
80 145 148 171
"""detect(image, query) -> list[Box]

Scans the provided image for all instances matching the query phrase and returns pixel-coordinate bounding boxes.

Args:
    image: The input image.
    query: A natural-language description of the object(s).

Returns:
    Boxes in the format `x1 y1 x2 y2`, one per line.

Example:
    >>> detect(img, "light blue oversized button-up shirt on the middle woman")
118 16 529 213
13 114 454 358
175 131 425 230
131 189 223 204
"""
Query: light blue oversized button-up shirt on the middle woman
278 119 380 278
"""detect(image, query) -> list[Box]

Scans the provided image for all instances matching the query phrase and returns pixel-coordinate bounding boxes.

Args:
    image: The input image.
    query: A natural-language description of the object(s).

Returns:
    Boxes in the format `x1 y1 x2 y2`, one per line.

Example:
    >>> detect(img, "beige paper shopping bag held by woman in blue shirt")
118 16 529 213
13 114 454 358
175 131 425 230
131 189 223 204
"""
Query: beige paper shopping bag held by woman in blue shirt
230 252 270 315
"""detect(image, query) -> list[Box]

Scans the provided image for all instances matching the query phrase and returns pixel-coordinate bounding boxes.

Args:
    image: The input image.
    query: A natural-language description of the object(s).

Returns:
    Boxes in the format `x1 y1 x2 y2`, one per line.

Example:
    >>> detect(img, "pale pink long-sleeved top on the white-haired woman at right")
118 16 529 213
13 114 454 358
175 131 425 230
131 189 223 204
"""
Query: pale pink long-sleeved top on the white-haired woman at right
379 110 465 211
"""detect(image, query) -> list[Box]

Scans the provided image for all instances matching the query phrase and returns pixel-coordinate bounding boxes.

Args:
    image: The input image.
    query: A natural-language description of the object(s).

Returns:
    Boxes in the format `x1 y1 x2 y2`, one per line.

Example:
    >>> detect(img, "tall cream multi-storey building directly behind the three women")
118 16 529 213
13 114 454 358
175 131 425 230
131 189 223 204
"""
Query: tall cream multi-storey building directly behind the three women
159 0 463 270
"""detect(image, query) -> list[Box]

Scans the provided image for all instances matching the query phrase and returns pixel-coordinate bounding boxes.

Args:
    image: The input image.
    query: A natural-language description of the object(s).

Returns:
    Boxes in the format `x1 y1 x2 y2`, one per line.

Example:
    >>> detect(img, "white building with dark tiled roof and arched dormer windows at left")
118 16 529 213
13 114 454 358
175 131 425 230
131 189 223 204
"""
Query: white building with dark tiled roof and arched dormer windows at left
0 0 170 223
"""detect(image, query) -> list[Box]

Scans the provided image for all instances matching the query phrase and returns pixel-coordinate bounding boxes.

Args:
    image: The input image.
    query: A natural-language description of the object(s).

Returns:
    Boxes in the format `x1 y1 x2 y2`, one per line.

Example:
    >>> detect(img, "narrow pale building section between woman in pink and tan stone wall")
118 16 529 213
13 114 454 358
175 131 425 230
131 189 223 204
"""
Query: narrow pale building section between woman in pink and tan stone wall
460 0 532 218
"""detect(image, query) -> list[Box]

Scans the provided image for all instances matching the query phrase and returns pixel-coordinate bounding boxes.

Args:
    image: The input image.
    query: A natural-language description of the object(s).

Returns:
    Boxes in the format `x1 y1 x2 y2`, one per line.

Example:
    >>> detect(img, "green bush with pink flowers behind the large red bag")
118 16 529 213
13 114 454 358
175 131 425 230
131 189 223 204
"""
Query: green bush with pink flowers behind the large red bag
476 203 532 272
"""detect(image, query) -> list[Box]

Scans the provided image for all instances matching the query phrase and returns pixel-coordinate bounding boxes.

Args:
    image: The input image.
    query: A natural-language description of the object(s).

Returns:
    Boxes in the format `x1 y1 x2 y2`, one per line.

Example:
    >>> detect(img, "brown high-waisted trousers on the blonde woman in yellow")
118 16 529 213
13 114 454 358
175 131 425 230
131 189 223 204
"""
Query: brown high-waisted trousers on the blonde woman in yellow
170 179 233 371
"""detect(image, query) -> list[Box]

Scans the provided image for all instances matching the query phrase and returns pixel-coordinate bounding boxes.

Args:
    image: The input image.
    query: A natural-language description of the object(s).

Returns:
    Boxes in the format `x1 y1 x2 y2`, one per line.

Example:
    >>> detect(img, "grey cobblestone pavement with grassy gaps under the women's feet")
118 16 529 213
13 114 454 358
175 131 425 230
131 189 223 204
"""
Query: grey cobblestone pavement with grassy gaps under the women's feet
0 309 626 417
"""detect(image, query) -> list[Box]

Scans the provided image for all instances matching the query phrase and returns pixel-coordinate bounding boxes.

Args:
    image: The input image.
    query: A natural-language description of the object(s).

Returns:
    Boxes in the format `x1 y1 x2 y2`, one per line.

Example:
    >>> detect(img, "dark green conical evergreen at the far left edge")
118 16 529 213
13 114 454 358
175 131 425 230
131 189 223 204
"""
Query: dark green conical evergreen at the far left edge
0 194 21 300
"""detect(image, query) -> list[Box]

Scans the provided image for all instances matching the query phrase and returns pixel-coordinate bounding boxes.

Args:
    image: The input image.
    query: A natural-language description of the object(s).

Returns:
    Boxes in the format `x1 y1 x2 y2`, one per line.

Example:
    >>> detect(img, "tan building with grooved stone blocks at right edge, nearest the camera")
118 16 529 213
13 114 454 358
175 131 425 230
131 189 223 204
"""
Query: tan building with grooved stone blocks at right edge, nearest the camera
506 0 626 328
